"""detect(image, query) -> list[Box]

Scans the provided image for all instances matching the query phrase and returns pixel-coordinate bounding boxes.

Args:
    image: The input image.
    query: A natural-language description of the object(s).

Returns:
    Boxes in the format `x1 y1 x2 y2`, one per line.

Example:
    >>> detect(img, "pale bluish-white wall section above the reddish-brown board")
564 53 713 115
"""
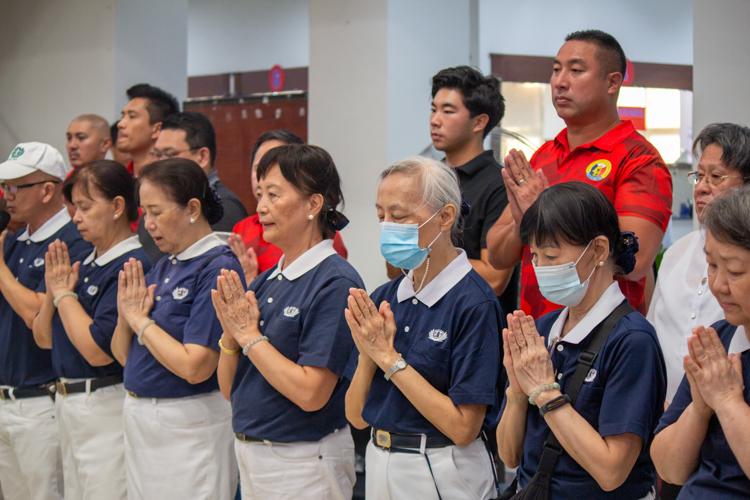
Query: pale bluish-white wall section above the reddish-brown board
188 0 310 76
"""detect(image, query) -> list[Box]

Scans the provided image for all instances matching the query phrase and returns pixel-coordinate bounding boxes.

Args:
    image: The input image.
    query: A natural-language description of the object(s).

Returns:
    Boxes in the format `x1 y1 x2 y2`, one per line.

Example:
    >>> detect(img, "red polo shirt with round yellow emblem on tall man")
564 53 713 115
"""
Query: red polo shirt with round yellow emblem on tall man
521 120 672 318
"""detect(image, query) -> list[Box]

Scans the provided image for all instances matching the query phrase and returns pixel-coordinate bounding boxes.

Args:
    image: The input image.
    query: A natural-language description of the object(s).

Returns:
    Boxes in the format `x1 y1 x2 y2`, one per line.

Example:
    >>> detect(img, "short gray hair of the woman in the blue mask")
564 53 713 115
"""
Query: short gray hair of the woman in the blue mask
380 156 463 242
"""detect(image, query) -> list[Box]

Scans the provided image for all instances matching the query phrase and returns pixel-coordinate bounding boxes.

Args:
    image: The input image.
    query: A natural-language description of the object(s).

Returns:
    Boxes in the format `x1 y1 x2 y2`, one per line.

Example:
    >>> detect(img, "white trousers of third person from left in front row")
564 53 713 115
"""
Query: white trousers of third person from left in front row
123 391 238 500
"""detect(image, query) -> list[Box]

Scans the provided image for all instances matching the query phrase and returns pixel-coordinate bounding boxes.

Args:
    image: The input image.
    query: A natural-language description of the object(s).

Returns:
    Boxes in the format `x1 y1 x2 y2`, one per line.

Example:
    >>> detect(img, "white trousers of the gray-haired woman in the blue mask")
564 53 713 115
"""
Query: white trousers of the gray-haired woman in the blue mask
365 439 495 500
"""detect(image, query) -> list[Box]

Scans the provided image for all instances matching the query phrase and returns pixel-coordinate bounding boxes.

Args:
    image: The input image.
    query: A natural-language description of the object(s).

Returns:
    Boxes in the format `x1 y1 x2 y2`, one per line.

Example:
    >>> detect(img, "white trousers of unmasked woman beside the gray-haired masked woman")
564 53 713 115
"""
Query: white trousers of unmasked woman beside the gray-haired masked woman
234 426 357 500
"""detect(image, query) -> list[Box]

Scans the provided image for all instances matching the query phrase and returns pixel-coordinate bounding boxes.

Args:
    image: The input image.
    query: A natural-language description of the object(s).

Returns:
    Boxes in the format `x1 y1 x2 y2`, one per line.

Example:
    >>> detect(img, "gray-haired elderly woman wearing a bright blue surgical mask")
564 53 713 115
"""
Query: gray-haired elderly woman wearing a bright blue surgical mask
345 157 503 499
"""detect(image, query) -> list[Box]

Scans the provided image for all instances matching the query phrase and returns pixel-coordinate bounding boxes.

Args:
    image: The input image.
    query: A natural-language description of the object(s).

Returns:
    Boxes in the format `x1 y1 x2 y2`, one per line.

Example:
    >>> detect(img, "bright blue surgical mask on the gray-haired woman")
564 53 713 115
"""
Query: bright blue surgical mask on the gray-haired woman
380 211 443 269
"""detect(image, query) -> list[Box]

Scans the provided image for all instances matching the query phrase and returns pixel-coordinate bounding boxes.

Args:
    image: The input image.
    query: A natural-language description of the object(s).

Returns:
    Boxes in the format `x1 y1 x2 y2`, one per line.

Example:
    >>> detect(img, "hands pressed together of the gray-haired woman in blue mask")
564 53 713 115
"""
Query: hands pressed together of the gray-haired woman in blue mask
344 288 401 372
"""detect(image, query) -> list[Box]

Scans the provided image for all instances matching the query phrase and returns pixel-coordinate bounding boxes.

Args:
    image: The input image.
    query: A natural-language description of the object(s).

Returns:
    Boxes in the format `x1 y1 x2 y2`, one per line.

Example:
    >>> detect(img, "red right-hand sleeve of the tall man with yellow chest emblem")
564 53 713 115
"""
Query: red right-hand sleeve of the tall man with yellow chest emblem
614 149 672 231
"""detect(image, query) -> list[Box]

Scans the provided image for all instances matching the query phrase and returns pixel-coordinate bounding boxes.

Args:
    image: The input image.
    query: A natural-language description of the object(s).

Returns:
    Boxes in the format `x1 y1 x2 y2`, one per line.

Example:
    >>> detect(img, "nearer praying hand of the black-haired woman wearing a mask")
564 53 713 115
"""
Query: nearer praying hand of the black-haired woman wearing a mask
508 311 555 396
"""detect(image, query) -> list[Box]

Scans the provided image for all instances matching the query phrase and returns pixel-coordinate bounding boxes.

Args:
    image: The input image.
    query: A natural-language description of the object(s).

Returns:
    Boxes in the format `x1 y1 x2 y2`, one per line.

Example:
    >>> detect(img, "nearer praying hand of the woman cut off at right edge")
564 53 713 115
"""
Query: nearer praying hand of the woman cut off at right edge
685 328 745 411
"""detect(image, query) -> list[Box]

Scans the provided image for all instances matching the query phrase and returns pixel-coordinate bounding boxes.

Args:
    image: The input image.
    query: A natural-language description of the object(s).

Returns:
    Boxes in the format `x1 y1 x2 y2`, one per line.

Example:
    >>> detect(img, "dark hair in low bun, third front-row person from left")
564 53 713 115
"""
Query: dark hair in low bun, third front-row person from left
138 158 224 225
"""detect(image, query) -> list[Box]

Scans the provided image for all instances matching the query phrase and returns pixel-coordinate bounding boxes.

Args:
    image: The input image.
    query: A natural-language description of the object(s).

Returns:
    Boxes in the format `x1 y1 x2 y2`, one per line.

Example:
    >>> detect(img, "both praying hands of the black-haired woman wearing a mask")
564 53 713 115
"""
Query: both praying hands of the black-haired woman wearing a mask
503 311 559 406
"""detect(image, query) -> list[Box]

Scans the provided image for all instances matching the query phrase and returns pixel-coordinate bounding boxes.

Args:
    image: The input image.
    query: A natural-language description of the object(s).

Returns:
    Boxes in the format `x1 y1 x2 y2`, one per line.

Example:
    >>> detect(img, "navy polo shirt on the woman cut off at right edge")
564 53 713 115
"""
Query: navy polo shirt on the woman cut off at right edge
656 320 750 500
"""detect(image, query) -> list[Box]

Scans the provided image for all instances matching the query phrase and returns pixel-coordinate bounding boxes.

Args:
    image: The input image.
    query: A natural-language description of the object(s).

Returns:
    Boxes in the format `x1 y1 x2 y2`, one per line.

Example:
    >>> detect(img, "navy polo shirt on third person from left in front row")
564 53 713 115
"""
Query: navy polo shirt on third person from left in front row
124 233 244 398
